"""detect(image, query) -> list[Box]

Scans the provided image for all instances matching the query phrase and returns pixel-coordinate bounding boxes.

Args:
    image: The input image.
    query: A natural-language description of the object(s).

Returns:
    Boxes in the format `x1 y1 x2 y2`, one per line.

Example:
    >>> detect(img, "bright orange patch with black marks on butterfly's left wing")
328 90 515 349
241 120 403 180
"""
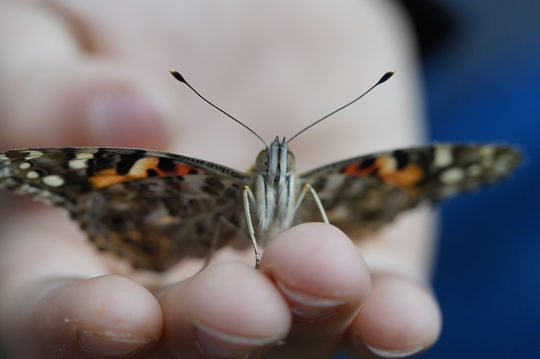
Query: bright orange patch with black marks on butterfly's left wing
89 157 197 189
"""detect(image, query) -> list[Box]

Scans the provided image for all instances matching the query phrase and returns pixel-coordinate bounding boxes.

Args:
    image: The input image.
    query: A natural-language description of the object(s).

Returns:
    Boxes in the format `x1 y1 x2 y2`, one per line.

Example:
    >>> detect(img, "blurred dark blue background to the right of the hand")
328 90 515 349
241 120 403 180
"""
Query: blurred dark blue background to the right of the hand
394 0 540 359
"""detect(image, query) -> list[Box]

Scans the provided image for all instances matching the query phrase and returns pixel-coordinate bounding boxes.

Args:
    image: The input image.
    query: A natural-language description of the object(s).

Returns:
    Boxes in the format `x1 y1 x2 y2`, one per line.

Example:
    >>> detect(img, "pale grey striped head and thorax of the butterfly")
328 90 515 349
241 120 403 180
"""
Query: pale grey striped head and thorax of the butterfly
252 137 297 233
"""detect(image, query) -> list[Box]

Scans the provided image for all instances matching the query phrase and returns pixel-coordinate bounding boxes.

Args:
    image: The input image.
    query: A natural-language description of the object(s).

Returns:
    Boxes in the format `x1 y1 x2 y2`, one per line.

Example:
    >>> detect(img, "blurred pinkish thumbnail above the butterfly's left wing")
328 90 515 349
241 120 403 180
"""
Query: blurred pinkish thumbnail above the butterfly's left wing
87 93 170 147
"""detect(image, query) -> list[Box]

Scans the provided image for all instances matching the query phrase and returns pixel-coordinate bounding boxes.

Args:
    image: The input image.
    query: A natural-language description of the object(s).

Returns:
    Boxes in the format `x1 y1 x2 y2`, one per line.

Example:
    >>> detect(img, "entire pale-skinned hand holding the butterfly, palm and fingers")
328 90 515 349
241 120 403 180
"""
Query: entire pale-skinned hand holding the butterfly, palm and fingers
0 0 441 358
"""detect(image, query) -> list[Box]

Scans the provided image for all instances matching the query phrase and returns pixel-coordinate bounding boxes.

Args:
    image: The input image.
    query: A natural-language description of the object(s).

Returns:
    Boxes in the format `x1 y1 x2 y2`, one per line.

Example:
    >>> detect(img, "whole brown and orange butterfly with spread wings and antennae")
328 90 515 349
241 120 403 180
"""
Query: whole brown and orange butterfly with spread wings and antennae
0 72 521 271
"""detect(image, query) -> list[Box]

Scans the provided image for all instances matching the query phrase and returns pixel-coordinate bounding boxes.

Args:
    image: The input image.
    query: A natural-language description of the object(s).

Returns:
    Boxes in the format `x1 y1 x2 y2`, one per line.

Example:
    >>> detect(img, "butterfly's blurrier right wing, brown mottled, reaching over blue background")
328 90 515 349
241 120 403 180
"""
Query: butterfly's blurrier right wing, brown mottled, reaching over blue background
298 144 521 236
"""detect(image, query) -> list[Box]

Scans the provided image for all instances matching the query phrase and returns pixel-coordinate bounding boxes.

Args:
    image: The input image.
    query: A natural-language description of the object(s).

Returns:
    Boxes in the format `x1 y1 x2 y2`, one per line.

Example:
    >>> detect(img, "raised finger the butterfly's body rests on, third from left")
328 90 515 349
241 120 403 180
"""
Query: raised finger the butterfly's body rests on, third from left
261 223 370 358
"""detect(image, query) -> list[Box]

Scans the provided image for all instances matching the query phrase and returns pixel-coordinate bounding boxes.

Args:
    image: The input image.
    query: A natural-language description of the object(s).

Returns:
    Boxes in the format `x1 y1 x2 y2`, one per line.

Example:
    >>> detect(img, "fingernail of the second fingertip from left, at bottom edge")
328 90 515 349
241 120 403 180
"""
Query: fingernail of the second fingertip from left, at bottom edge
195 322 276 358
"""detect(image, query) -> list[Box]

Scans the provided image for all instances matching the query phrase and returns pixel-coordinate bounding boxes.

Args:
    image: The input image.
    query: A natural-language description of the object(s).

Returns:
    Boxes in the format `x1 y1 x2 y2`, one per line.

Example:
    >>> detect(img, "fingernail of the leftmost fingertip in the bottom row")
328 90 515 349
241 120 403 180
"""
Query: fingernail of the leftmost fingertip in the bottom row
77 329 150 358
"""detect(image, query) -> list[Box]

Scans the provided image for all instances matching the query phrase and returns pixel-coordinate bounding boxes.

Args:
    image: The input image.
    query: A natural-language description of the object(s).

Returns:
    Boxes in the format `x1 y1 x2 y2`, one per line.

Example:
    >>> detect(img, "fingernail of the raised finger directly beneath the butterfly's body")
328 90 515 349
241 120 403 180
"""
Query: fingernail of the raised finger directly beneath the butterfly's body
275 279 348 320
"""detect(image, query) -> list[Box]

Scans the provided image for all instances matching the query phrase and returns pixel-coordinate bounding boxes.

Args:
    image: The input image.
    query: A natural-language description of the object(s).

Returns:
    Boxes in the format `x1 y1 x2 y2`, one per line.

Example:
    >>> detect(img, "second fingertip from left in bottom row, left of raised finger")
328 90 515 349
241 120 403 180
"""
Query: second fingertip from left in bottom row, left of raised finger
153 262 290 358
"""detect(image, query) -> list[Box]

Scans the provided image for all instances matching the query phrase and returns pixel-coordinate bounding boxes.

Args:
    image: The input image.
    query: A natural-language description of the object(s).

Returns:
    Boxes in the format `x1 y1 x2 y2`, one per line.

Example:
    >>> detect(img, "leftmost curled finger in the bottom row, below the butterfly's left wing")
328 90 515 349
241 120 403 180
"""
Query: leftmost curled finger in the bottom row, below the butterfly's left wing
0 275 162 359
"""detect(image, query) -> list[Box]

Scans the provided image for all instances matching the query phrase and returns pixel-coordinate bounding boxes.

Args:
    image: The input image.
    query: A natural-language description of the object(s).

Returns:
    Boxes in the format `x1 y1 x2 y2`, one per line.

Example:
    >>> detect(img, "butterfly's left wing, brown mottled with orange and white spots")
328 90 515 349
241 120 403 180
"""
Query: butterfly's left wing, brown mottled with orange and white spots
0 148 250 270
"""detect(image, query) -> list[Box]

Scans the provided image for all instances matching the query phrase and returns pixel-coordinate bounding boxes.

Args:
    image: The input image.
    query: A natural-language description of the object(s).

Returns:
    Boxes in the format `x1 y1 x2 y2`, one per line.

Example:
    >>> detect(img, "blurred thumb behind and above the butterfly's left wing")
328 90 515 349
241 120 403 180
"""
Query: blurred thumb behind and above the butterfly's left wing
0 62 168 148
